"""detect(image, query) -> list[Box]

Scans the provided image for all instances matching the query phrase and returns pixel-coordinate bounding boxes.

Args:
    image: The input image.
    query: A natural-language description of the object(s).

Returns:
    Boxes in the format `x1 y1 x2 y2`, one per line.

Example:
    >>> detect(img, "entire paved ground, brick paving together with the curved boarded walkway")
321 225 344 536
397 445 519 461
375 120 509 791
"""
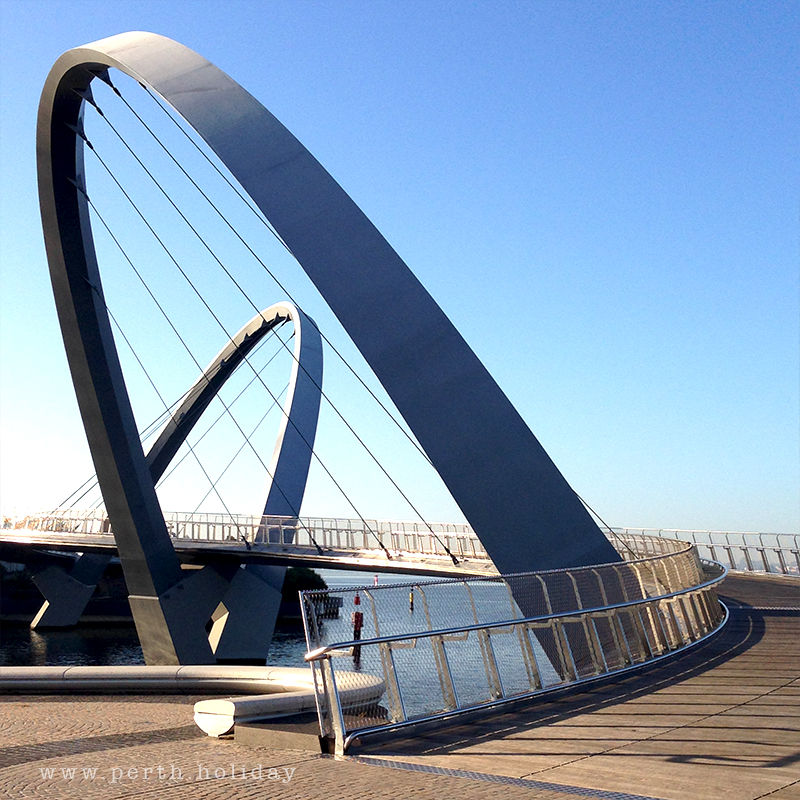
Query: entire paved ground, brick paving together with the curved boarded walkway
0 575 800 800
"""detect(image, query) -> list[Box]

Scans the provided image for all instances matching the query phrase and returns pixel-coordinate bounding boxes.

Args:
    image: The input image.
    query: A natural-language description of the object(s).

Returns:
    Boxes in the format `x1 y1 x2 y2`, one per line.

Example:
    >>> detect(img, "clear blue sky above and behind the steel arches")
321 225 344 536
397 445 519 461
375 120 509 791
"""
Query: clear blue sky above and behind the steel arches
0 0 800 532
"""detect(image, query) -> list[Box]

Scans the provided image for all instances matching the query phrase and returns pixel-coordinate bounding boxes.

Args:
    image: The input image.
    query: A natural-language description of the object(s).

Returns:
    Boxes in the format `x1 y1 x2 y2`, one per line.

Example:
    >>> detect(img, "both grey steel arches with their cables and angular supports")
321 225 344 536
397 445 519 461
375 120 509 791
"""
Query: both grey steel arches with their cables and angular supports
31 32 636 665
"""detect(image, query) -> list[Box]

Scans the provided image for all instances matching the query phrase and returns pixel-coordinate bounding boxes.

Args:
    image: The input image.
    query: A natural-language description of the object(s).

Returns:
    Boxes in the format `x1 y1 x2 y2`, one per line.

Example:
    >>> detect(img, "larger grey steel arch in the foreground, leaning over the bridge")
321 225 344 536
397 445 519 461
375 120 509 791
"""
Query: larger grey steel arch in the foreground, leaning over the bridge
37 32 619 664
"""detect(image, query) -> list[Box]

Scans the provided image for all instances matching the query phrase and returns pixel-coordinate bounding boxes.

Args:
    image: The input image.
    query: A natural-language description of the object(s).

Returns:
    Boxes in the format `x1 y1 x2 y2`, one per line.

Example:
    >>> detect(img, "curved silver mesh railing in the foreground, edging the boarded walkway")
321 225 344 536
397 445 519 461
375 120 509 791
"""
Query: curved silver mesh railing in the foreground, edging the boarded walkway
301 535 726 753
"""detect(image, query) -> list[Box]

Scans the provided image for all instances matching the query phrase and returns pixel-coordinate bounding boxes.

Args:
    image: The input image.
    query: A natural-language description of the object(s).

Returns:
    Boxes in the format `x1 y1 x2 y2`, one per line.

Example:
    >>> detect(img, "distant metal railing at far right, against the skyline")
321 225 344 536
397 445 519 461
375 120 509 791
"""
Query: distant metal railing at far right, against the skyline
611 528 800 577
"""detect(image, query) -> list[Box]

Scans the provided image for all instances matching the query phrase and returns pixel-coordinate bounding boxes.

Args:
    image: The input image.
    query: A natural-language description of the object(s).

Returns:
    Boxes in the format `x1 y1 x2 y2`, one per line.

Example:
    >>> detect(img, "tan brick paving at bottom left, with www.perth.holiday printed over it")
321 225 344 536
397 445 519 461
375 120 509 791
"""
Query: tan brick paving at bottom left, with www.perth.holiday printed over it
0 696 601 800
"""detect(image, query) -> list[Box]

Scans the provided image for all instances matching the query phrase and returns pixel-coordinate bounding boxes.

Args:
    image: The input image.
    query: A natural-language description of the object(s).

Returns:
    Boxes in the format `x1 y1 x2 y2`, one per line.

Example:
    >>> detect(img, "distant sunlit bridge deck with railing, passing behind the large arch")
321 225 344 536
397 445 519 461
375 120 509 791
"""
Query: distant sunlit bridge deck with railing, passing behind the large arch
0 509 497 577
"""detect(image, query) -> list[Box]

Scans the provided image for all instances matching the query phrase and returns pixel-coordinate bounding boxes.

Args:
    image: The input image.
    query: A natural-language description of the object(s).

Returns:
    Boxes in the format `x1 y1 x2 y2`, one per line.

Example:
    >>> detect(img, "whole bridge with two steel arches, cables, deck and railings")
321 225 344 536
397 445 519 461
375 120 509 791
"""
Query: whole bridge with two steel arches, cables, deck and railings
0 33 800 788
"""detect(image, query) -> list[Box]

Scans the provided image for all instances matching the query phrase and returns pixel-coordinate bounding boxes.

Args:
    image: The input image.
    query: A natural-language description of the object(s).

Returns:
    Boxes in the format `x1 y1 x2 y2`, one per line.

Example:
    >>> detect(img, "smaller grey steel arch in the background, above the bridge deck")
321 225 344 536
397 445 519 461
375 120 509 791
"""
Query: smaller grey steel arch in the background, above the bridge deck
147 302 322 517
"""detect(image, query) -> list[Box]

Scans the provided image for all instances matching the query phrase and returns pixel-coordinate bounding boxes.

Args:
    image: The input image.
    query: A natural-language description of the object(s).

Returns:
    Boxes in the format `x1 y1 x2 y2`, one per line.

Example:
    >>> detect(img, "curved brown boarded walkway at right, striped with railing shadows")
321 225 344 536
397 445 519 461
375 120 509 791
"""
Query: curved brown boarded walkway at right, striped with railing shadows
350 573 800 800
